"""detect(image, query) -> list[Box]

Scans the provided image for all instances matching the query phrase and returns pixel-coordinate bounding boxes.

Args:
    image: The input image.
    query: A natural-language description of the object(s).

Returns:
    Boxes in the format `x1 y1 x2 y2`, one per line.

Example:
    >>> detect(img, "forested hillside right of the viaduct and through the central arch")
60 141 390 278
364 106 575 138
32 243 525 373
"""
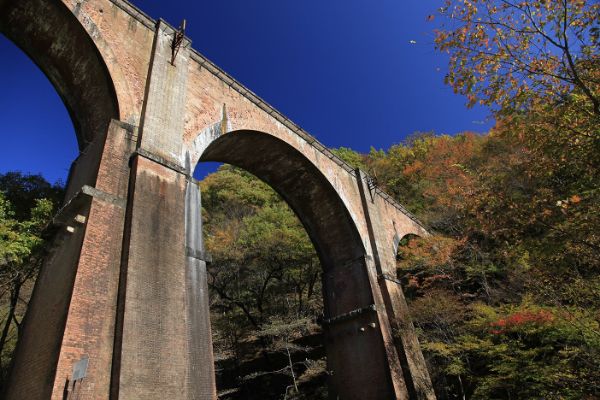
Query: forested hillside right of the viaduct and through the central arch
203 110 600 399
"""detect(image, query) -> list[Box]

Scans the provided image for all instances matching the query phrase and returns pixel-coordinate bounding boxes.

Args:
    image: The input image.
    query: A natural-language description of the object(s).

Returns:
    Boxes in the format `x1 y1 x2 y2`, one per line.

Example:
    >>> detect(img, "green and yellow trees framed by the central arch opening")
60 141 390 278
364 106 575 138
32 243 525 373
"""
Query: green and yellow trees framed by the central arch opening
202 167 321 329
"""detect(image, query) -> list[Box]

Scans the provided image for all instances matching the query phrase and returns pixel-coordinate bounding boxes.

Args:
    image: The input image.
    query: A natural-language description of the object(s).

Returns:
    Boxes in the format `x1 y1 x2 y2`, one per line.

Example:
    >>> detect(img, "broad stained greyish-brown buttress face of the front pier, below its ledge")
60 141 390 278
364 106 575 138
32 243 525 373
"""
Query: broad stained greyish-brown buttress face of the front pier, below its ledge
119 157 188 399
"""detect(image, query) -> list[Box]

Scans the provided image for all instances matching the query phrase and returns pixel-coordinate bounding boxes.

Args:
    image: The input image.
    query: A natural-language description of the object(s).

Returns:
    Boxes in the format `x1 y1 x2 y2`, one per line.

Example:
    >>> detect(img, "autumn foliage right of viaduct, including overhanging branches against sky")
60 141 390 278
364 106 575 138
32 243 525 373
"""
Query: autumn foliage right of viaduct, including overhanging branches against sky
338 0 600 399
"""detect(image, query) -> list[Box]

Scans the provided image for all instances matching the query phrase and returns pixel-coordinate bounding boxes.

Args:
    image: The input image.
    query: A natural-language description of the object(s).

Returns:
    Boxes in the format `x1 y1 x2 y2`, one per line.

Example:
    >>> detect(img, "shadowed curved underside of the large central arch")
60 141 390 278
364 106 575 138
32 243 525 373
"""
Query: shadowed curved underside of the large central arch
200 131 365 271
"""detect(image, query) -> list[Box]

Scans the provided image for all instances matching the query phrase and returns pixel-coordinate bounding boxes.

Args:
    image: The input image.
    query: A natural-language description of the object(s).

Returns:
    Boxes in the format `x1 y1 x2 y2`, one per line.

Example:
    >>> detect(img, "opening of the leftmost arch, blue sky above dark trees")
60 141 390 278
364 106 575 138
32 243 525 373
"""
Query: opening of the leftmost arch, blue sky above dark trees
0 36 72 382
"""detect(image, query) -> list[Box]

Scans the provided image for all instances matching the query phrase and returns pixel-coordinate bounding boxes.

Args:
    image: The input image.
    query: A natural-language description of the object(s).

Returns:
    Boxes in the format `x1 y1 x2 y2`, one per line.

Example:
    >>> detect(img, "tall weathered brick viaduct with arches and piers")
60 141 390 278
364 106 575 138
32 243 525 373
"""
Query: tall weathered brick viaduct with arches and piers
0 0 434 400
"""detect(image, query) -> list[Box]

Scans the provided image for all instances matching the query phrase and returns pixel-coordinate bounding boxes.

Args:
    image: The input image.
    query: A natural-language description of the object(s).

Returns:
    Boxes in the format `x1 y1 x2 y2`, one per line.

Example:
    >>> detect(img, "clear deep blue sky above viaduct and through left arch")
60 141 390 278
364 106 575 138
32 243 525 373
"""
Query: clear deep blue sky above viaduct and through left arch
0 0 491 181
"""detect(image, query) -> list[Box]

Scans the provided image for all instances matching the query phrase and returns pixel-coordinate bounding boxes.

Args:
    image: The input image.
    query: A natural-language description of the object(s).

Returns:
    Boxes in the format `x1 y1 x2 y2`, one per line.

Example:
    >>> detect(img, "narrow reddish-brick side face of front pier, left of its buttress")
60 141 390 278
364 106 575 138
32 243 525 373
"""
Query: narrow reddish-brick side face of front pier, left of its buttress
52 120 135 400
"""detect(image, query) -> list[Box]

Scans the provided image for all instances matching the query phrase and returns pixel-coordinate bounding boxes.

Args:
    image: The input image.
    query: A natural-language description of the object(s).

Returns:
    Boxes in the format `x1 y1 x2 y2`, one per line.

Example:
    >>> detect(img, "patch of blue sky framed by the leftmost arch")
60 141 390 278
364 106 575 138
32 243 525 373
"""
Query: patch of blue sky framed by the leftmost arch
0 36 78 185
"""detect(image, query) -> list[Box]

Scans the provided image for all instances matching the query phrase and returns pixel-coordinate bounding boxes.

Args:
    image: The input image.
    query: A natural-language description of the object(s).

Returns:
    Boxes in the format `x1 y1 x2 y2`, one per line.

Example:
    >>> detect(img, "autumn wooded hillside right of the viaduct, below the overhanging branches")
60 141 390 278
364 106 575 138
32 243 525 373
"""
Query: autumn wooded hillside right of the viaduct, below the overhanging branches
367 122 600 399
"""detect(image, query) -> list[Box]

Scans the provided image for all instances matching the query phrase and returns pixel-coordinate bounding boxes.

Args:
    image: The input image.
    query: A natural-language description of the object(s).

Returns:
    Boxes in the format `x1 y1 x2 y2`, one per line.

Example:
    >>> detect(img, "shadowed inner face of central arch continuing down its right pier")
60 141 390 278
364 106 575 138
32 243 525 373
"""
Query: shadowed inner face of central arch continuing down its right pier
199 130 404 399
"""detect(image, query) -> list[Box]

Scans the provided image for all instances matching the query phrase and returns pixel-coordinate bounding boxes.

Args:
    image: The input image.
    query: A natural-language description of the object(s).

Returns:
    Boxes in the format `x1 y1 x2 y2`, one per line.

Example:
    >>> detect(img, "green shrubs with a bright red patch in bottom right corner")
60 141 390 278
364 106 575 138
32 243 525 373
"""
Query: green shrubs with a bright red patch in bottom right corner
416 299 600 399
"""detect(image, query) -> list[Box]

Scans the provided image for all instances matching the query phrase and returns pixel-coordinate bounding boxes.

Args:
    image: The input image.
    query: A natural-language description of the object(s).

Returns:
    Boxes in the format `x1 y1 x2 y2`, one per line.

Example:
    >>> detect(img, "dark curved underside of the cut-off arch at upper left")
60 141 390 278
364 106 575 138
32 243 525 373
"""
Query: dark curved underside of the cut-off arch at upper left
0 0 119 149
